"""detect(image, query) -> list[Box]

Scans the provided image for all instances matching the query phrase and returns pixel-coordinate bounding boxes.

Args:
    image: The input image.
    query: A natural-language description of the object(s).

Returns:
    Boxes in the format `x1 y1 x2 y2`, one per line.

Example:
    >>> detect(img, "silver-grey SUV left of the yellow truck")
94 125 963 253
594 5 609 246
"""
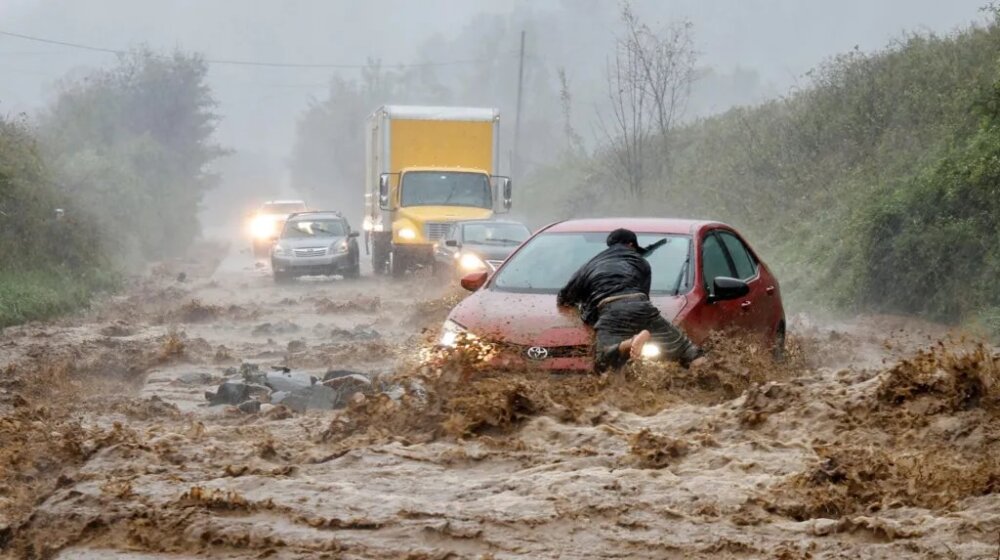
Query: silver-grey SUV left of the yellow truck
271 212 361 282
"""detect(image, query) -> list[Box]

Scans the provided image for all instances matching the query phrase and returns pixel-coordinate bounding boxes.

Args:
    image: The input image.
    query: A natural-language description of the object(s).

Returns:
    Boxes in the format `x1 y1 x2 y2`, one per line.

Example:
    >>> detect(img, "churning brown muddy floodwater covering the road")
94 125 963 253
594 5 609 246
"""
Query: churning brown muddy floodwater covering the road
0 243 1000 559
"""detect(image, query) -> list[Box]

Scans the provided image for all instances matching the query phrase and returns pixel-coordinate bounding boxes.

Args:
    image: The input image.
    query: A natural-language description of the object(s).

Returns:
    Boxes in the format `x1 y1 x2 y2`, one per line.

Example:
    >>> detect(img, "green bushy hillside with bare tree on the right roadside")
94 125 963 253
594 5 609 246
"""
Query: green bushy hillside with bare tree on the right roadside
518 8 1000 332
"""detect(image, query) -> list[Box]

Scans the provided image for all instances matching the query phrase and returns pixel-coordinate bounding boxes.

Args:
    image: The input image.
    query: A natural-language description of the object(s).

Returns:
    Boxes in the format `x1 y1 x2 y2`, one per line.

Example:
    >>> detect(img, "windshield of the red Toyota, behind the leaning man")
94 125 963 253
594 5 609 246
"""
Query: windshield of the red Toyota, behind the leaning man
493 232 691 294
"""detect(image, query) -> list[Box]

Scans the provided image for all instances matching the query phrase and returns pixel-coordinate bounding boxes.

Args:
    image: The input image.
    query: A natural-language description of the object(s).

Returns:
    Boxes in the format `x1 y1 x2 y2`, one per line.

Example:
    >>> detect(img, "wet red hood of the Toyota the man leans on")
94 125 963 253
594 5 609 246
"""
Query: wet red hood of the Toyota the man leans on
448 290 687 347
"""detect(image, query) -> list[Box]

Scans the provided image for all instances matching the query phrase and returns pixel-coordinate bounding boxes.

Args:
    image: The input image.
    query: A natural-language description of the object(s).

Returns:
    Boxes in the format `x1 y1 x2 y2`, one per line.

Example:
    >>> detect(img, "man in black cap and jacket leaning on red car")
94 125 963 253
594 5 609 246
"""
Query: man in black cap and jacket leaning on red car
556 229 705 371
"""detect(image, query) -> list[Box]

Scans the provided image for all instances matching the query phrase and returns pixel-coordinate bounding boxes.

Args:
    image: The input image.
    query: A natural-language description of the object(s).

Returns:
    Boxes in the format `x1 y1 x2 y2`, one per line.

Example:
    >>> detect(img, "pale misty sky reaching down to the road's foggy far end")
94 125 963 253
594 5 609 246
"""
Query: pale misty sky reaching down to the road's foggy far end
0 0 982 221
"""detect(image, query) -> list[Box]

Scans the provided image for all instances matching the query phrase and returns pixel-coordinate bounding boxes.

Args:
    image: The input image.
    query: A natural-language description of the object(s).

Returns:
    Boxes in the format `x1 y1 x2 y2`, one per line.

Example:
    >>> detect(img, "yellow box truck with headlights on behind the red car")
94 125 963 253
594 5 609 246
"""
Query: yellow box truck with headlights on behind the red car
362 105 511 276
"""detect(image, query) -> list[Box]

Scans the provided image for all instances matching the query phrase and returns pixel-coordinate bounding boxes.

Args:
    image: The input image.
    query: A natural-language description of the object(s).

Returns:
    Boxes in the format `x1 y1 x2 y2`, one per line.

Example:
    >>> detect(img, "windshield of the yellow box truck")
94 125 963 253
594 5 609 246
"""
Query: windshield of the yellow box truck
400 171 493 208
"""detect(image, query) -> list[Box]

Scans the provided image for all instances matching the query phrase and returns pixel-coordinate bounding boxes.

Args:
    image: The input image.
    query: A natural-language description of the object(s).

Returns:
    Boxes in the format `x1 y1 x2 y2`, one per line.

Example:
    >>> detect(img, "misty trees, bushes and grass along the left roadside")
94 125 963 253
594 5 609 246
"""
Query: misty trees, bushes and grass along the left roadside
0 50 223 328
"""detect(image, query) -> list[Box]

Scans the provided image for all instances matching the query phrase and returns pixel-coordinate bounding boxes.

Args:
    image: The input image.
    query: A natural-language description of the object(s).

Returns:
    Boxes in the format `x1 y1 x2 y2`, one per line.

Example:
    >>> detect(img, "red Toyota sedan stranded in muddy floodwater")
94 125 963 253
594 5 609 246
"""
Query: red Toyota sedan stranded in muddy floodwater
441 218 785 370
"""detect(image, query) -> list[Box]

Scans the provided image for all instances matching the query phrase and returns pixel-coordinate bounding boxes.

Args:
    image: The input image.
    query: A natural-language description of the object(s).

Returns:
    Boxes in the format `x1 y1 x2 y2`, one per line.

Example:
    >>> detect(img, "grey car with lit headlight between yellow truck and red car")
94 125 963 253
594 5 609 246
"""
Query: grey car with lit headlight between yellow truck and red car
434 220 531 278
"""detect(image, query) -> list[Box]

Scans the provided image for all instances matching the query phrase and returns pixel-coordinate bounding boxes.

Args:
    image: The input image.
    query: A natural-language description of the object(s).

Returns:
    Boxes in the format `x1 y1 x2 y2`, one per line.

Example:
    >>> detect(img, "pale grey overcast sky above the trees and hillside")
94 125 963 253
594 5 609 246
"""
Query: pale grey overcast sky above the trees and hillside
0 0 985 188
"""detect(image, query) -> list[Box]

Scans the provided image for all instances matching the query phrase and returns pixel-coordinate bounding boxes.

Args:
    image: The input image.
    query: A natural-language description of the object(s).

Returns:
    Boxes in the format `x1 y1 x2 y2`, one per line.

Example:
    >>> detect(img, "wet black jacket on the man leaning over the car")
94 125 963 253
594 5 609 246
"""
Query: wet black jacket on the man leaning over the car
556 244 653 326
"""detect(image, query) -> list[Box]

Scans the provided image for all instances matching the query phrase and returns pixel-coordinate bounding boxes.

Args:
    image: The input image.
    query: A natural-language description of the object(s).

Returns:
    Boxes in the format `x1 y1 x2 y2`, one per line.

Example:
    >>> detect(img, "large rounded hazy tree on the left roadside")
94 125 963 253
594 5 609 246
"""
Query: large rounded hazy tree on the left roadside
41 50 225 263
